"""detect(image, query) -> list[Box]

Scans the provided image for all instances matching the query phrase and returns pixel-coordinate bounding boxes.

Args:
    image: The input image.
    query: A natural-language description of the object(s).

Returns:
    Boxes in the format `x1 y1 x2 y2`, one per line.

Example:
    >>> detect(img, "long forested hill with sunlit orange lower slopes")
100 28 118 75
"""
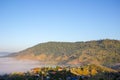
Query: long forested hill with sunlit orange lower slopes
11 39 120 65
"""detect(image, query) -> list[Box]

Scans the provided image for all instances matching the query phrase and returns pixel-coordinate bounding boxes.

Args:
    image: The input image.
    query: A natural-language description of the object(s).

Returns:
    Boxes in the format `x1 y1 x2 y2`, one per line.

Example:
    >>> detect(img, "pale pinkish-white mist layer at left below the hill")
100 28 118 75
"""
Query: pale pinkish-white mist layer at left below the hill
0 58 40 74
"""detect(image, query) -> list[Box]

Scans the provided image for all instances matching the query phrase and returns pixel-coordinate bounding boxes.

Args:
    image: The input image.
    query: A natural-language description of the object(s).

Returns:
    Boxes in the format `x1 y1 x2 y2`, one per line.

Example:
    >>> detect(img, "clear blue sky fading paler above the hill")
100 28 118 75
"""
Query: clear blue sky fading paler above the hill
0 0 120 52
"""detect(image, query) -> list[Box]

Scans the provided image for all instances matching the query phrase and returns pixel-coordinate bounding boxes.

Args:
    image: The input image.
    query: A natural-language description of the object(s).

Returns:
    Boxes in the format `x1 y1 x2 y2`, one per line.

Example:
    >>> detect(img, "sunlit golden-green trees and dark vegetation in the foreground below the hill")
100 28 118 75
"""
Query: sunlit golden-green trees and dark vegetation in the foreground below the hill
0 65 120 80
